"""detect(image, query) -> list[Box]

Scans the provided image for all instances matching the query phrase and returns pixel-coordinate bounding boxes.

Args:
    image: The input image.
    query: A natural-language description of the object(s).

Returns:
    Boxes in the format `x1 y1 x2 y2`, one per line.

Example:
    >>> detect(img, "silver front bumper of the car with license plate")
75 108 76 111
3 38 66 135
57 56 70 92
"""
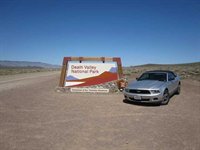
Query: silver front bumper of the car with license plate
124 91 163 103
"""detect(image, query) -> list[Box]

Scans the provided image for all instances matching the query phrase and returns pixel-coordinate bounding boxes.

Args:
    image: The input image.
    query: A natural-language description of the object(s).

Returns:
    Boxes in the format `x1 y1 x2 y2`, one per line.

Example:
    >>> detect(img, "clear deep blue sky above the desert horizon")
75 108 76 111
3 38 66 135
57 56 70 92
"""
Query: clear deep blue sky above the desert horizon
0 0 200 66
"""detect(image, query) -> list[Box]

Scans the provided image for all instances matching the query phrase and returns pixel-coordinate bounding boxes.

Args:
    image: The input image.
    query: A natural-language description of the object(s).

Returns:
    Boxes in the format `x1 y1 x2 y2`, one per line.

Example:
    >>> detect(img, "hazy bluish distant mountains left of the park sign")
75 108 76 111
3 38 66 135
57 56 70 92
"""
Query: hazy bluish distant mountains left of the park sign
0 60 61 68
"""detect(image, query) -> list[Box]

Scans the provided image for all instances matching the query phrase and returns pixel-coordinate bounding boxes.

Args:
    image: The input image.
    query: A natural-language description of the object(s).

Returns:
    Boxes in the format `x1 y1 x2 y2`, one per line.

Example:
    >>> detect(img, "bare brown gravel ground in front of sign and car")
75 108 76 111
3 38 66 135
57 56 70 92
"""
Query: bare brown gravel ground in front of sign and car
0 72 200 150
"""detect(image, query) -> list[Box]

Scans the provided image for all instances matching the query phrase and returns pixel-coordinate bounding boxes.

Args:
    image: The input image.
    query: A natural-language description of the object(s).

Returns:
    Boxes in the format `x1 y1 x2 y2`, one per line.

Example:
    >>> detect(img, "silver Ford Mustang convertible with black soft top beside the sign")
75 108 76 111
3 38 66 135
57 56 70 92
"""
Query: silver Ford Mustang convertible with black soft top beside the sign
123 70 181 105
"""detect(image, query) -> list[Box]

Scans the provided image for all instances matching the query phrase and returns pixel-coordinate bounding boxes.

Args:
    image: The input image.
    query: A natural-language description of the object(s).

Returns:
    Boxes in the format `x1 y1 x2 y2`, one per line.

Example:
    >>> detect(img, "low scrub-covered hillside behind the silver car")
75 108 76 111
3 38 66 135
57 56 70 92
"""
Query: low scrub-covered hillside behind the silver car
123 62 200 81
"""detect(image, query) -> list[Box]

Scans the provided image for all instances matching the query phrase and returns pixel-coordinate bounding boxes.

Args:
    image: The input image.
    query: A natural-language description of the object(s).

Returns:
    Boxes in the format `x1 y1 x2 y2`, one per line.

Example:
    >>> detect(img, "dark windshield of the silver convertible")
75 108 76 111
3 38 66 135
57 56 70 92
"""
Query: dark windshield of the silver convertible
138 72 167 81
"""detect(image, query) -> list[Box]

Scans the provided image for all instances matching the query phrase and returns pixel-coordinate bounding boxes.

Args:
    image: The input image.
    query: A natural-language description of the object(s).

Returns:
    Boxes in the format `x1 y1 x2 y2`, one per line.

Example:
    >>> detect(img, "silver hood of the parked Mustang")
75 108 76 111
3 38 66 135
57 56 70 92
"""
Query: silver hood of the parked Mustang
128 80 165 89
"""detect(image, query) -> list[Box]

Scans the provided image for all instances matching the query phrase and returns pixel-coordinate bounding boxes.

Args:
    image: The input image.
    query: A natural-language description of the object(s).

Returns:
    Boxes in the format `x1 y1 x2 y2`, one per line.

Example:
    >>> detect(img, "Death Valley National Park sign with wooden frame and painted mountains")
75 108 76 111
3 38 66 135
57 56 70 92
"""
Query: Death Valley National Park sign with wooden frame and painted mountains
59 57 123 90
